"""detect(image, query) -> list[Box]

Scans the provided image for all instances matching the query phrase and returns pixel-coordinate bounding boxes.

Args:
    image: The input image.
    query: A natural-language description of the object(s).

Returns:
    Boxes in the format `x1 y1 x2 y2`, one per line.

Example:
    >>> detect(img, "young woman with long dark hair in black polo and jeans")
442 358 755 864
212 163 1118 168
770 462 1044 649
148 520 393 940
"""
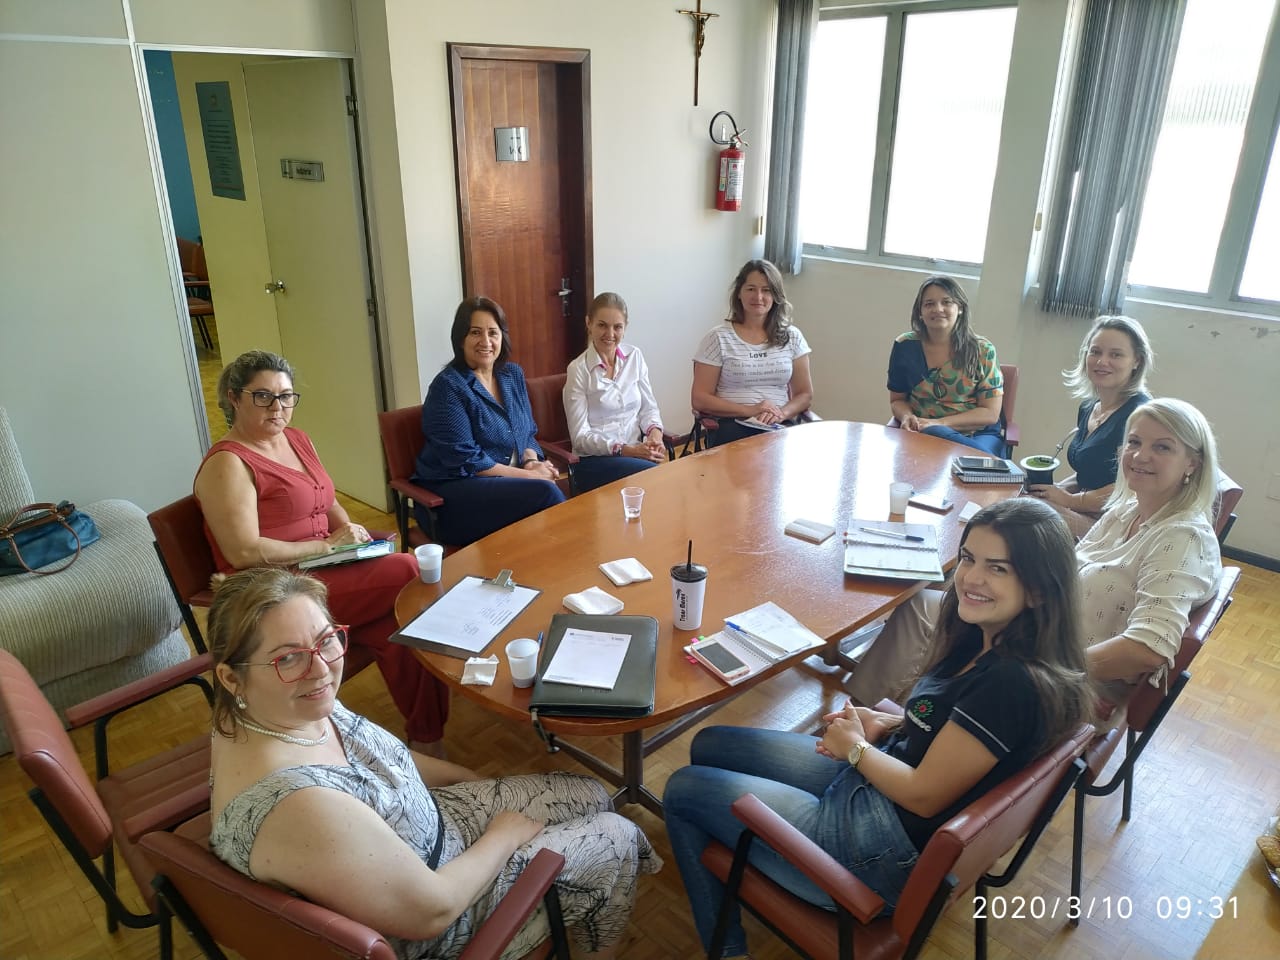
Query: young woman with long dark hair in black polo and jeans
663 498 1092 957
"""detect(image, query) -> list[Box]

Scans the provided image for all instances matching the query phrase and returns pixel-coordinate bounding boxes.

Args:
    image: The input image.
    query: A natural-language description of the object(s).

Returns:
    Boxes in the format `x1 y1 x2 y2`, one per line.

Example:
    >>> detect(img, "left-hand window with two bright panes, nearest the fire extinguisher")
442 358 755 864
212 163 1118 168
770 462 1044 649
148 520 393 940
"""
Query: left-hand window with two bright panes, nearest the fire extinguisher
800 4 1016 264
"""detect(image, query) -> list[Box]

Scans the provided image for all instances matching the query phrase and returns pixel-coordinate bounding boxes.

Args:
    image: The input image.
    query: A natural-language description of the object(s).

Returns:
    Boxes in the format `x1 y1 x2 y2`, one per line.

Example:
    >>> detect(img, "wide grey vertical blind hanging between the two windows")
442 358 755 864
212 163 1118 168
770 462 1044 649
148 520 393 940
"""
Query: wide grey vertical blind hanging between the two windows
1041 0 1187 317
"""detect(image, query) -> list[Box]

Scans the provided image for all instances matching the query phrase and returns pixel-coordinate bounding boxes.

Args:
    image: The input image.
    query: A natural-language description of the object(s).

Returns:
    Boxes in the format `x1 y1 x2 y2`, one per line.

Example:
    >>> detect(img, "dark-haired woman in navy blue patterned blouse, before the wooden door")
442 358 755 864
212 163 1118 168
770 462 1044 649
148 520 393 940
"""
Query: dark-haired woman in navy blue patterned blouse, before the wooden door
413 297 564 547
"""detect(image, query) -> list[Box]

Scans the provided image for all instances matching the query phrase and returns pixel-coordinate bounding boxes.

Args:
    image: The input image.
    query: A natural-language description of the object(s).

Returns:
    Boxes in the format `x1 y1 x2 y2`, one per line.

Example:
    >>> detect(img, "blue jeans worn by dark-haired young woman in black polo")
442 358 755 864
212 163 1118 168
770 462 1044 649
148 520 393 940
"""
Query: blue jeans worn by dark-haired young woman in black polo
663 727 919 956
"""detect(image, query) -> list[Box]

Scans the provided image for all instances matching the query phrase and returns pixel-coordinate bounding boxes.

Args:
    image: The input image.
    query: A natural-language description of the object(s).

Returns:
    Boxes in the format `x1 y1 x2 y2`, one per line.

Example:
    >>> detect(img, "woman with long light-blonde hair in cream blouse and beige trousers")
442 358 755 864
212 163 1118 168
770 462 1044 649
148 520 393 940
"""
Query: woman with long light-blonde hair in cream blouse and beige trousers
847 398 1222 704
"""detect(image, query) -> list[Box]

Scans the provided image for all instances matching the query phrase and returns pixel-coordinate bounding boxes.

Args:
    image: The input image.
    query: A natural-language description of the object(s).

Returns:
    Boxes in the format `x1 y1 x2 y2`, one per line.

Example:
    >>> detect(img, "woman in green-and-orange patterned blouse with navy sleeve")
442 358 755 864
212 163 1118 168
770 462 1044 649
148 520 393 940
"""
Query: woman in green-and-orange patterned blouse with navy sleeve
888 276 1005 457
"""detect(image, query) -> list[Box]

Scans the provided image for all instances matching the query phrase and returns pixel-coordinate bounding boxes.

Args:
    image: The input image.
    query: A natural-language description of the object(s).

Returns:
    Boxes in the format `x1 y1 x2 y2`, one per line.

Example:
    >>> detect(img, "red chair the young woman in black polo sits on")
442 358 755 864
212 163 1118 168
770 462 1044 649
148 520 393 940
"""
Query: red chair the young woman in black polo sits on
703 723 1093 960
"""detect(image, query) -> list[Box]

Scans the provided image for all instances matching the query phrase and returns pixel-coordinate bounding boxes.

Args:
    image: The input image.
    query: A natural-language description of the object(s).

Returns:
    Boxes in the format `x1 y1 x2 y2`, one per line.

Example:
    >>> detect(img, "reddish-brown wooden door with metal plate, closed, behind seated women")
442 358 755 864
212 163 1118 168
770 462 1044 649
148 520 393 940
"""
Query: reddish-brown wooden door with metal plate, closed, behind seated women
449 44 594 376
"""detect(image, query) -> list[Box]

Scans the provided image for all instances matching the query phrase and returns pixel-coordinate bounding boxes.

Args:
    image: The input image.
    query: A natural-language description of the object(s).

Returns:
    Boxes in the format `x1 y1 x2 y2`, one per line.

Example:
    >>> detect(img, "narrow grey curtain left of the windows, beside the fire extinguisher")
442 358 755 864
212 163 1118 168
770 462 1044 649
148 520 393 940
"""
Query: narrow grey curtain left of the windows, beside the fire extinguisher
764 0 818 274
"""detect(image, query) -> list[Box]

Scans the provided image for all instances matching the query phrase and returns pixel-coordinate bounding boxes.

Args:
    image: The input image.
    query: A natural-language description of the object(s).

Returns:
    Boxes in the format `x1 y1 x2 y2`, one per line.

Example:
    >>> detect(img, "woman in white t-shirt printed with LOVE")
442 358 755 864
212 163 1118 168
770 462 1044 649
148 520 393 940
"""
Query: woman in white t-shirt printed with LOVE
691 260 813 445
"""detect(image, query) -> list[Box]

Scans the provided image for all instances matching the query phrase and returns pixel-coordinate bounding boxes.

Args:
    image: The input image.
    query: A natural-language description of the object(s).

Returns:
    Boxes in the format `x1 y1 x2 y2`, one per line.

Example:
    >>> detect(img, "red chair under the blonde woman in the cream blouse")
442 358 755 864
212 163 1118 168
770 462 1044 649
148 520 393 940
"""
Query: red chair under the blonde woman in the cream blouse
1071 567 1240 925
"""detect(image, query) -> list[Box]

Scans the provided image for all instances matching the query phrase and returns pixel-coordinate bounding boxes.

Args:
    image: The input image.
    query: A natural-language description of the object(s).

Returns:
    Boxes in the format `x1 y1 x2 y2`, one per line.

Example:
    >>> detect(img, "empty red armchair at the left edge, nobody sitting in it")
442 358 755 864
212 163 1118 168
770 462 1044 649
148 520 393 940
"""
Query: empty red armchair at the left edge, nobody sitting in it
0 650 212 960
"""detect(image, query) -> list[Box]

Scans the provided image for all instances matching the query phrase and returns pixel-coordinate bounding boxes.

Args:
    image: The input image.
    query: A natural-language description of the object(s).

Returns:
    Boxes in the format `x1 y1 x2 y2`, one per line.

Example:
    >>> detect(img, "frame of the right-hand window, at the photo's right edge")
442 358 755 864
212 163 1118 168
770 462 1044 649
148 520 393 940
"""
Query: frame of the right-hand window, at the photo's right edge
1129 3 1280 316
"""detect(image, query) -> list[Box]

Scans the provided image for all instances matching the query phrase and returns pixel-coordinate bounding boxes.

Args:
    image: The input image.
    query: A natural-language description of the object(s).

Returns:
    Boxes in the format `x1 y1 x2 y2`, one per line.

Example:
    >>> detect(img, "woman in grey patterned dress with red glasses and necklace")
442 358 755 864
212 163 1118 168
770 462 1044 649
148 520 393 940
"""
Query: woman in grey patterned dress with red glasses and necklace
209 570 662 959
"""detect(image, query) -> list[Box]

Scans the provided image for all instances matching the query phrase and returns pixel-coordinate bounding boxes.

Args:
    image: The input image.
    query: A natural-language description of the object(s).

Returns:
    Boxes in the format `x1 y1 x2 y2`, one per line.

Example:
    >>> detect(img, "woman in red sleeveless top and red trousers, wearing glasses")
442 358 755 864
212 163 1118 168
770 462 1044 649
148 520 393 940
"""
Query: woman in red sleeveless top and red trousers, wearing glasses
195 351 449 754
